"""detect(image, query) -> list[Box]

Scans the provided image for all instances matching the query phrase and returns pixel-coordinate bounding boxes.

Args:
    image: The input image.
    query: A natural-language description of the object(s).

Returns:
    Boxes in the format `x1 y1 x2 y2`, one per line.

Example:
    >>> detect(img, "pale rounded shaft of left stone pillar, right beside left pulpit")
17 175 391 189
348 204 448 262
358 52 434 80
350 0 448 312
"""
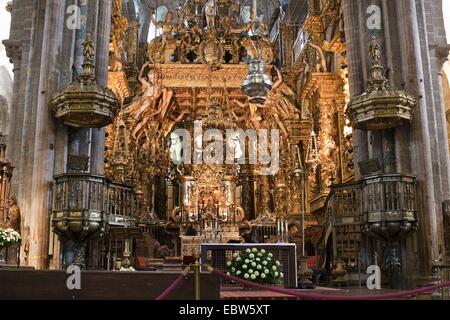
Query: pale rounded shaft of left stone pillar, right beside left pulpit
29 0 65 269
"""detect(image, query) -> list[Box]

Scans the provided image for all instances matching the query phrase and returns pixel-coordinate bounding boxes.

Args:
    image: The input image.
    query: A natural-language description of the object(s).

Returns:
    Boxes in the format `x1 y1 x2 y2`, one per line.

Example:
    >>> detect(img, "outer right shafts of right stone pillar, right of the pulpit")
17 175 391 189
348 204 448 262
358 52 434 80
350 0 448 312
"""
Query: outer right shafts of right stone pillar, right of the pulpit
396 0 450 278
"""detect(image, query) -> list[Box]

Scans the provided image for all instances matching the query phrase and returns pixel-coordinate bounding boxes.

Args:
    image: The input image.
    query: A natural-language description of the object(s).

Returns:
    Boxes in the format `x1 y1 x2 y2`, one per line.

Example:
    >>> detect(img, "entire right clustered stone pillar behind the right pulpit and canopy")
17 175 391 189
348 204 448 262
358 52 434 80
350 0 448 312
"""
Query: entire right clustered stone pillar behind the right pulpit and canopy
342 0 450 285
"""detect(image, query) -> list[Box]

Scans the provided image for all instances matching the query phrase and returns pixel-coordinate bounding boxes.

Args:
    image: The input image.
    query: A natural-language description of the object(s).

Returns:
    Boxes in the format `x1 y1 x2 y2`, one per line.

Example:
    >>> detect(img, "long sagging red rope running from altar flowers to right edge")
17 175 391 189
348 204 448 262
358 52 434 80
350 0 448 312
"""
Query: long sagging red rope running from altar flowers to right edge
205 266 450 300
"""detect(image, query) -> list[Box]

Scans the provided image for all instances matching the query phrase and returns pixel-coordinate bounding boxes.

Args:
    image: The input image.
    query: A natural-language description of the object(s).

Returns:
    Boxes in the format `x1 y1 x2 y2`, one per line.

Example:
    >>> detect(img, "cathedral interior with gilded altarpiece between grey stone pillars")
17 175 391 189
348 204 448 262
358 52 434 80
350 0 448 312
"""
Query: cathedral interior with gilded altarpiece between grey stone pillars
0 0 450 294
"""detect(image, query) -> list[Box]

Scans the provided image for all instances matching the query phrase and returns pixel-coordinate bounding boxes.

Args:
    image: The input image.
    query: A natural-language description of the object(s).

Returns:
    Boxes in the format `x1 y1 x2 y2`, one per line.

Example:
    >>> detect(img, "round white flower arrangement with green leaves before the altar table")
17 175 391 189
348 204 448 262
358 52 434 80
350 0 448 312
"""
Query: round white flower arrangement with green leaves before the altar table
227 248 284 284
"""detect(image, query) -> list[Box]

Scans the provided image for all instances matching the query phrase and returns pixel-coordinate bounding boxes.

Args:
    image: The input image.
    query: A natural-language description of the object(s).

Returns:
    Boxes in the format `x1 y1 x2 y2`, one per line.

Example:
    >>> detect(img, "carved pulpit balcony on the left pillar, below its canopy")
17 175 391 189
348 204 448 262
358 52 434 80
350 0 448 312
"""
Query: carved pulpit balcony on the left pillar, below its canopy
52 173 135 241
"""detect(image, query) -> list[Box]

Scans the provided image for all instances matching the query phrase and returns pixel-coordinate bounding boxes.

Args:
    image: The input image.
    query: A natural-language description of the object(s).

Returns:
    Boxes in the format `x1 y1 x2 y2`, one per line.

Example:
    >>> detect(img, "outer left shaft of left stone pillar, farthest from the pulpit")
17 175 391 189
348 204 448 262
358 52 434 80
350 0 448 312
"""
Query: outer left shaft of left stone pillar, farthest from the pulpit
4 0 45 266
